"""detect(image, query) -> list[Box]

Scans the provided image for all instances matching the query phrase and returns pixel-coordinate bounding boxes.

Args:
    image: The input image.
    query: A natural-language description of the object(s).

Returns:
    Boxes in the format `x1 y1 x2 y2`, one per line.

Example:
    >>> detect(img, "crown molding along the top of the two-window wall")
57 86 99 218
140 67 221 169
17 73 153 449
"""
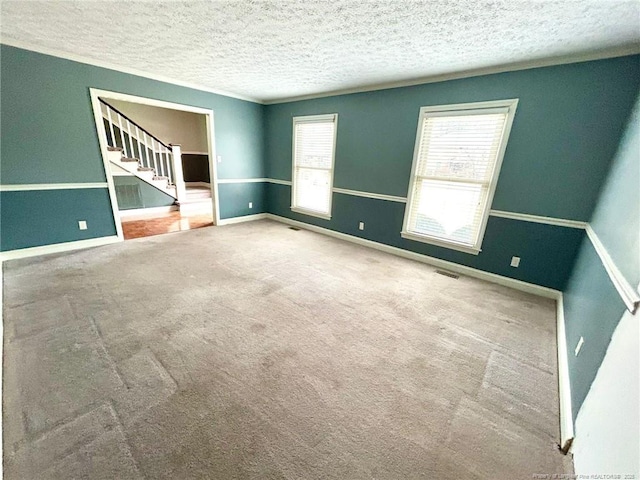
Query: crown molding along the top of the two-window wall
262 44 640 105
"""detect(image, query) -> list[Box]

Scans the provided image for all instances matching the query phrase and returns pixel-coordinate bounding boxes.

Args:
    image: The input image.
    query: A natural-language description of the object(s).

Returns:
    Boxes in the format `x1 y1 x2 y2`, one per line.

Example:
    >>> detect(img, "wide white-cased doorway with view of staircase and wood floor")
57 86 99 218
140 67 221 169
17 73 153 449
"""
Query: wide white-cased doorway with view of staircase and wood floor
90 88 220 240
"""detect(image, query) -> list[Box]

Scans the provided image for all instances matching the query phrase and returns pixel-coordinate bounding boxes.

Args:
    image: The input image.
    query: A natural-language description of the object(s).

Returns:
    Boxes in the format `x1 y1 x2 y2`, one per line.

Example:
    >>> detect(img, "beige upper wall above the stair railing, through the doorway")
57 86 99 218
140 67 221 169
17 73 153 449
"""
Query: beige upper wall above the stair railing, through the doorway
106 99 208 153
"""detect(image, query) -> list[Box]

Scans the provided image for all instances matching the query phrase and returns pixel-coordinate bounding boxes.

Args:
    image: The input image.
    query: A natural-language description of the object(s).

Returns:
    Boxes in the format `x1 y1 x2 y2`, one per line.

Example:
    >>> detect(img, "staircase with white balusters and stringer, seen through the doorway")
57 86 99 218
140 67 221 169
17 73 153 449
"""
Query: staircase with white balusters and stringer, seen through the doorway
100 99 188 203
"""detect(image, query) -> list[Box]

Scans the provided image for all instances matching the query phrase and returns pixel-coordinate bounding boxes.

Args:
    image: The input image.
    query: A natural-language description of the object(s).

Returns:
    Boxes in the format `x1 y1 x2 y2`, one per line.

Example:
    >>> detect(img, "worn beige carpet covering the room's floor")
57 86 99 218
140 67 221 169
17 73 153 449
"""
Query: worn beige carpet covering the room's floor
3 220 571 480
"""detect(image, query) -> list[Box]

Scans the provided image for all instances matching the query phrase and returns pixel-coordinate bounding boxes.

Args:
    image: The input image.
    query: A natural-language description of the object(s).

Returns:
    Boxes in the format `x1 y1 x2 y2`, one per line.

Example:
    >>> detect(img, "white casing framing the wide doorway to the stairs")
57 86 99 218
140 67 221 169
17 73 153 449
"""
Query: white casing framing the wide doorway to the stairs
89 88 220 232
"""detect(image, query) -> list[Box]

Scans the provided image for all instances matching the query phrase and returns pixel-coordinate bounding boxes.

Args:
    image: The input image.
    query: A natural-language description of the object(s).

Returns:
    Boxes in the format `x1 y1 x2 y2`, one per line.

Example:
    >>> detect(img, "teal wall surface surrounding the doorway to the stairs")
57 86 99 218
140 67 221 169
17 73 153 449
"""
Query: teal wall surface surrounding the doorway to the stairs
0 45 265 250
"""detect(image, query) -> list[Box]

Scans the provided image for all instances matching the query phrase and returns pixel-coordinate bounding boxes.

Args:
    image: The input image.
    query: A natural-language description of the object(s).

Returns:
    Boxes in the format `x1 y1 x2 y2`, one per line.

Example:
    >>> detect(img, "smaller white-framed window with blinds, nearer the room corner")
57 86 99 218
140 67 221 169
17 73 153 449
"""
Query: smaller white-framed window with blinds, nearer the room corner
291 114 338 220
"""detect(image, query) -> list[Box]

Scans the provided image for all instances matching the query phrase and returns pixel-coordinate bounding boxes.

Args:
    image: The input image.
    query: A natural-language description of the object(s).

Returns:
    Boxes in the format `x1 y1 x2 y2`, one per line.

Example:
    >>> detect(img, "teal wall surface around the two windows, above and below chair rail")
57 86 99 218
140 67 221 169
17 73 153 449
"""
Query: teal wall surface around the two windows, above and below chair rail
265 56 640 290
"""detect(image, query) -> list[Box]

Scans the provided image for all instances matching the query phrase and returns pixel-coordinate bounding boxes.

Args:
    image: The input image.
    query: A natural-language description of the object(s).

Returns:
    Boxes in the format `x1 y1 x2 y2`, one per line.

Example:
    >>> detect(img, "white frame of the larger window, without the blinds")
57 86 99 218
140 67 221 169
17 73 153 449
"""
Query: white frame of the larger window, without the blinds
400 98 518 255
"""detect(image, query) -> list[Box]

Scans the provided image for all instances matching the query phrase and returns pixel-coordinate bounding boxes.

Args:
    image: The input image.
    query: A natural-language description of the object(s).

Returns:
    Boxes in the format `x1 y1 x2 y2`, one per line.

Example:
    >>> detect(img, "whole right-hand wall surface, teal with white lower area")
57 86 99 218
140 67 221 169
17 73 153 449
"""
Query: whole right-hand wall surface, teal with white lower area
564 97 640 476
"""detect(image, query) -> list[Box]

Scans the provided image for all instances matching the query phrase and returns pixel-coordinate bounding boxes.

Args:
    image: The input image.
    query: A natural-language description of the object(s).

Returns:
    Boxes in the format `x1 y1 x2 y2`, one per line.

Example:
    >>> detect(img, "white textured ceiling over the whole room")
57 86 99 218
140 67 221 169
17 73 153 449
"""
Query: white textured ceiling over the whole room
1 0 640 101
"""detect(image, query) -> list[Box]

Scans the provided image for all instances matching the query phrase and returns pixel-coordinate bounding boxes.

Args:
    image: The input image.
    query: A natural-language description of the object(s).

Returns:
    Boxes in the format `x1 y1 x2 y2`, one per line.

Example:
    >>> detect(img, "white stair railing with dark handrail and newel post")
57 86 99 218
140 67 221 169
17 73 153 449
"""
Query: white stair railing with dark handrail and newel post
100 99 180 190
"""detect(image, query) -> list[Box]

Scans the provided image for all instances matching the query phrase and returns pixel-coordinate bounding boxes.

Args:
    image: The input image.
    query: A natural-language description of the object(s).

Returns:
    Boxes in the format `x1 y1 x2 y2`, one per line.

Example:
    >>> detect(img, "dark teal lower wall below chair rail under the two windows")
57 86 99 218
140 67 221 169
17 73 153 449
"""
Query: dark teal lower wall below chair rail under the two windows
267 184 584 290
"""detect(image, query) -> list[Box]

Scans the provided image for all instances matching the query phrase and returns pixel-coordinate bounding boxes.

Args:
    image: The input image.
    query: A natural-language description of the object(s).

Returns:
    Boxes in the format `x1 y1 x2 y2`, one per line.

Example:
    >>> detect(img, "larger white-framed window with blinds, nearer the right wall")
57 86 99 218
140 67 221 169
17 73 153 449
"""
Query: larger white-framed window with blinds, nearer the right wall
402 100 518 255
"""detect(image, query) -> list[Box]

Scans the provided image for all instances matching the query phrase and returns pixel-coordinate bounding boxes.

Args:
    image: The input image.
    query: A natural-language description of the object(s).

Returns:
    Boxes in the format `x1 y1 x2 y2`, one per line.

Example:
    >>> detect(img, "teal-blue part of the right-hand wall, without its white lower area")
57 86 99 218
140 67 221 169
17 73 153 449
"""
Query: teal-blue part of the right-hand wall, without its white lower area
564 93 640 419
